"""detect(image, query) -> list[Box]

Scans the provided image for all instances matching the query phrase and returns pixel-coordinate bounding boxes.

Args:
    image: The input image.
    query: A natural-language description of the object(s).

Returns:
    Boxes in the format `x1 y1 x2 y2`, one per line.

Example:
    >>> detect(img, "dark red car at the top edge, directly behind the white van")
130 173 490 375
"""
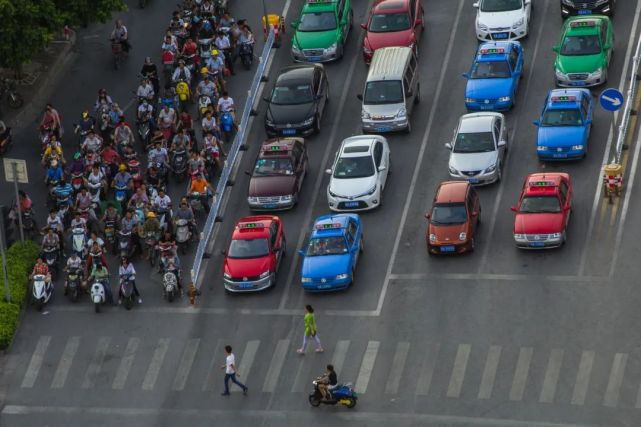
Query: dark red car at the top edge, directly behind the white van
361 0 425 64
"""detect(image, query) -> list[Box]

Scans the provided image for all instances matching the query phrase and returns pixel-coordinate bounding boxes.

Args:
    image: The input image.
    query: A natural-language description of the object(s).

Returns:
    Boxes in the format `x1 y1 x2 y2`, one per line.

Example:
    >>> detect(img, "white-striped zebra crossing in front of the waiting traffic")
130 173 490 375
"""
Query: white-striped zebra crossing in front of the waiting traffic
14 336 641 409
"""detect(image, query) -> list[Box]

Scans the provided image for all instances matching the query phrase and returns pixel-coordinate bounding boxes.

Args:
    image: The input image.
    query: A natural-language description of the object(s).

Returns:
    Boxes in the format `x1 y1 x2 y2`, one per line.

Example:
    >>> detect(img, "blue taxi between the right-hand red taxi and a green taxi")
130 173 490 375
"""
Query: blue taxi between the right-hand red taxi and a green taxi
534 89 592 160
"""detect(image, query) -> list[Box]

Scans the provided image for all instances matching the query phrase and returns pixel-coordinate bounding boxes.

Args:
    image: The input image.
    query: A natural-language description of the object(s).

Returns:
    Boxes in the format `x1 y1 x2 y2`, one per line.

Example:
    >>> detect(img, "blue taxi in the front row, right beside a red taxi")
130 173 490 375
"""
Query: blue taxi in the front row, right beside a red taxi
298 213 363 292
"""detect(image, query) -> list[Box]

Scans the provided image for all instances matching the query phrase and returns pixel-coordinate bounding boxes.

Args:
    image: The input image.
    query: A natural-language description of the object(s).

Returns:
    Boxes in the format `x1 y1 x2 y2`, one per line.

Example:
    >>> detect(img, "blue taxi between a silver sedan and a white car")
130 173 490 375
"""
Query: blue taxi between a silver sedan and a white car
463 41 523 111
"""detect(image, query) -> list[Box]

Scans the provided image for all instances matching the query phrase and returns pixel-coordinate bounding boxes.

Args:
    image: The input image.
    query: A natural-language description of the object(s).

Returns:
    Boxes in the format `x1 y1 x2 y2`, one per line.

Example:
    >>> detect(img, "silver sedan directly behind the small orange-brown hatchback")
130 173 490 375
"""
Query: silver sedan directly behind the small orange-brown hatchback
445 112 507 185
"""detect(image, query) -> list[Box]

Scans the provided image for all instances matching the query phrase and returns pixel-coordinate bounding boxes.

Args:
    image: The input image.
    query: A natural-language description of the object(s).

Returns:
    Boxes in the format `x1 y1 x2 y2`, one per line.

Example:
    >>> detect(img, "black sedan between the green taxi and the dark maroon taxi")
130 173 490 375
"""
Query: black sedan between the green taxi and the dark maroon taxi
265 64 329 137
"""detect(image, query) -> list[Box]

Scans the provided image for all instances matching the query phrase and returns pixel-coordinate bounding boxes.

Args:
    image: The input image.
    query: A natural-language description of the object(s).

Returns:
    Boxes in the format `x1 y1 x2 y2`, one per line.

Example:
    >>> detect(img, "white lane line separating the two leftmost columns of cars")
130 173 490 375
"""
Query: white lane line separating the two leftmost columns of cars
278 21 368 309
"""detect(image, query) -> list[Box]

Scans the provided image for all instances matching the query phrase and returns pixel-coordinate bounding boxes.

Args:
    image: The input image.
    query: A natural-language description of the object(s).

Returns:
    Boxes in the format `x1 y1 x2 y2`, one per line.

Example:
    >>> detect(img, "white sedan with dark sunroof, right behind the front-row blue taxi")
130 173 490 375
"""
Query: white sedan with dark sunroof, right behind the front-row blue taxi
325 135 391 212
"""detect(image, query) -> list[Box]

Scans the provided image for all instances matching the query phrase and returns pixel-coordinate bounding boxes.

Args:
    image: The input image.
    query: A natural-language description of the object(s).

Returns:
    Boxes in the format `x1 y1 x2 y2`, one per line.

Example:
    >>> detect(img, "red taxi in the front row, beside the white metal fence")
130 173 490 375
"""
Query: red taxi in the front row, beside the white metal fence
223 215 285 292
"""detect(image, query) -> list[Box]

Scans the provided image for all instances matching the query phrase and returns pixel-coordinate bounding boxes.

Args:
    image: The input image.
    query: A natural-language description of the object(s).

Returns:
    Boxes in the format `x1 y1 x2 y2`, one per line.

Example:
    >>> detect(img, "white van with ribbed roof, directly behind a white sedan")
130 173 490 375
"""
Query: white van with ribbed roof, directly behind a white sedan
358 47 421 133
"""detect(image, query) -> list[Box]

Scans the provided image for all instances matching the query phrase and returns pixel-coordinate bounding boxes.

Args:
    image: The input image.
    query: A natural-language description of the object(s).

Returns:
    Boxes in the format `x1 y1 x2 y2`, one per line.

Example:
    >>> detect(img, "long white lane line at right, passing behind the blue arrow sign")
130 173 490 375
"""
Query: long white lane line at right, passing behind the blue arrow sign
579 0 641 275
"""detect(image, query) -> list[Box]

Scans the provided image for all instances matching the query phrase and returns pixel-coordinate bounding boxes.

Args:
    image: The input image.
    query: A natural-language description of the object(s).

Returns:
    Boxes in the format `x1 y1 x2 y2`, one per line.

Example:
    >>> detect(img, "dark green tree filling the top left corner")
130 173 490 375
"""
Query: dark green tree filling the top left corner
0 0 62 74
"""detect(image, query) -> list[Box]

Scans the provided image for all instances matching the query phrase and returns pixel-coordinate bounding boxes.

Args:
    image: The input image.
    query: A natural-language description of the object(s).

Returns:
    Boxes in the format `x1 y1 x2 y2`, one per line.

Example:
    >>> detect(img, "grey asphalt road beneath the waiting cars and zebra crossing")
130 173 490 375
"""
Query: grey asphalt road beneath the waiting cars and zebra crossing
0 0 641 426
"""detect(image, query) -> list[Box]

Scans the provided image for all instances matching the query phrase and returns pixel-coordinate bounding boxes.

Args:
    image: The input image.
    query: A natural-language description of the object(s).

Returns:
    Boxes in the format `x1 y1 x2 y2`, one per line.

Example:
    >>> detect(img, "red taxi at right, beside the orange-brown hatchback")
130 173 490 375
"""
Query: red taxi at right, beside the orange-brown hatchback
512 173 572 249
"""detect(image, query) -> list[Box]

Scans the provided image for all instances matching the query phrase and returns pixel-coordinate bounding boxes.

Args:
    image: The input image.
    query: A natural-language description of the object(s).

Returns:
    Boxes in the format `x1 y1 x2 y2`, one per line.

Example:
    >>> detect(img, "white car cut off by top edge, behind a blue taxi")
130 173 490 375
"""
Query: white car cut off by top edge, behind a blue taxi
474 0 532 41
